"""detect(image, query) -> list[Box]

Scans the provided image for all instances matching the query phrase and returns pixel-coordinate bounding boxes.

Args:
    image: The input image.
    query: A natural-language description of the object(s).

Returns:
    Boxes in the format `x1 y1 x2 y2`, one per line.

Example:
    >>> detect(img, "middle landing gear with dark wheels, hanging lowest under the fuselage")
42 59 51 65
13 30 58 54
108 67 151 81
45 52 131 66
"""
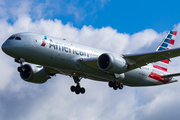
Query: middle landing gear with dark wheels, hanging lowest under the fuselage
71 76 85 94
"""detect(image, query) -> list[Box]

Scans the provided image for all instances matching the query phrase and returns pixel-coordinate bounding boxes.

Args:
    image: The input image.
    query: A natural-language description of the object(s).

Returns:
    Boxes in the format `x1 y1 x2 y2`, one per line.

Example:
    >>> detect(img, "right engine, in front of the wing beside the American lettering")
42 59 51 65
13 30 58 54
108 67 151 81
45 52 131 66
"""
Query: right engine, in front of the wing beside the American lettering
97 53 128 74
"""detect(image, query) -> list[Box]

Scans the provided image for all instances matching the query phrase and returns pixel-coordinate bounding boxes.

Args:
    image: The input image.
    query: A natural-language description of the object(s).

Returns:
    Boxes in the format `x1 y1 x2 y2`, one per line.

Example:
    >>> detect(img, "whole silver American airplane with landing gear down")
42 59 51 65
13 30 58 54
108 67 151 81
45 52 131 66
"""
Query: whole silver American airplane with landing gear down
1 30 180 94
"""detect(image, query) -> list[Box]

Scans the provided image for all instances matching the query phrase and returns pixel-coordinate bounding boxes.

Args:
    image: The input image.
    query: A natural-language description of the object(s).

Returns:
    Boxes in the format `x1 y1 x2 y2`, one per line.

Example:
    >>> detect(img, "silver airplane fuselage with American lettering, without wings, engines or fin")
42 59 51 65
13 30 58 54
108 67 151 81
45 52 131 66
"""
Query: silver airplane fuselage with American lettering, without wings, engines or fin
3 33 176 86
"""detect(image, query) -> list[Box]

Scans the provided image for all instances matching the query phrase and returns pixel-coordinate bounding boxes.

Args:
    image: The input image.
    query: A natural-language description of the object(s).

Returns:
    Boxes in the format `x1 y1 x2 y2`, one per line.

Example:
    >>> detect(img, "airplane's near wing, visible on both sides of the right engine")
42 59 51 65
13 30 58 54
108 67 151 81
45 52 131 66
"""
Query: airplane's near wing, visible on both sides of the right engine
79 48 180 72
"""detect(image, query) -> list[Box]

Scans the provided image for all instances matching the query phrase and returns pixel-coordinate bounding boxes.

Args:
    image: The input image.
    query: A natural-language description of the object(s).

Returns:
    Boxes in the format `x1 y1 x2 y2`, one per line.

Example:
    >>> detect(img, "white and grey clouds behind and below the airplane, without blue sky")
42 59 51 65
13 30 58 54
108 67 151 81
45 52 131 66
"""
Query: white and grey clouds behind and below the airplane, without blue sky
0 14 180 120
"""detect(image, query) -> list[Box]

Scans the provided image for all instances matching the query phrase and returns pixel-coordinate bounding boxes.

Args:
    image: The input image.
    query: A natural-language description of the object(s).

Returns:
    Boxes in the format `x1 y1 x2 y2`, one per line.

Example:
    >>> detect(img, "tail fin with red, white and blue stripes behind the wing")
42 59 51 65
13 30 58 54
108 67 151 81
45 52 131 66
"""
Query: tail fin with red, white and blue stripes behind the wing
153 31 177 72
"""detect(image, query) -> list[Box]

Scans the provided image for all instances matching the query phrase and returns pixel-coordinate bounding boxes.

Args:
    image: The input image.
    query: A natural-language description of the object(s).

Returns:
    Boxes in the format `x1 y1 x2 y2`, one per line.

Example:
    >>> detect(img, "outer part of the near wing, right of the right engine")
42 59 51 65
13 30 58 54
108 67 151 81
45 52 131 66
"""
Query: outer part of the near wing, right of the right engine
123 48 180 72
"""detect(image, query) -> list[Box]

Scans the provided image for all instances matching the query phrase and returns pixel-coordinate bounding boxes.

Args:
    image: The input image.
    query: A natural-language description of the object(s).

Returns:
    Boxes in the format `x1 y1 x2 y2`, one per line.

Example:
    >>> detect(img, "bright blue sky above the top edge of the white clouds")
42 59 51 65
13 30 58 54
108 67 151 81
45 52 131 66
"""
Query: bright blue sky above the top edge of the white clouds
3 0 180 34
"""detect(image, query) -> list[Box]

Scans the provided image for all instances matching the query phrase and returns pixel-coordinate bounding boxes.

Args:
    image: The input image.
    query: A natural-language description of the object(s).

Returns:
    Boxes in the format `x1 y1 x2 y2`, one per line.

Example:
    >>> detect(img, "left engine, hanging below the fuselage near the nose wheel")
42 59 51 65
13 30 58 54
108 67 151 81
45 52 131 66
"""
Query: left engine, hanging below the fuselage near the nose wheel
20 64 50 83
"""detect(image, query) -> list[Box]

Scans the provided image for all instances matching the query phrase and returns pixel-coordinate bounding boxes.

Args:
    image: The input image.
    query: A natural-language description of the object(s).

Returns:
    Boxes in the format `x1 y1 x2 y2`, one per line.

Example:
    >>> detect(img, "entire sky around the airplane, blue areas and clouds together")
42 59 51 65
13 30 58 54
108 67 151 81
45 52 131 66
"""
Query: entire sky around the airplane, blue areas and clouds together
0 0 180 120
